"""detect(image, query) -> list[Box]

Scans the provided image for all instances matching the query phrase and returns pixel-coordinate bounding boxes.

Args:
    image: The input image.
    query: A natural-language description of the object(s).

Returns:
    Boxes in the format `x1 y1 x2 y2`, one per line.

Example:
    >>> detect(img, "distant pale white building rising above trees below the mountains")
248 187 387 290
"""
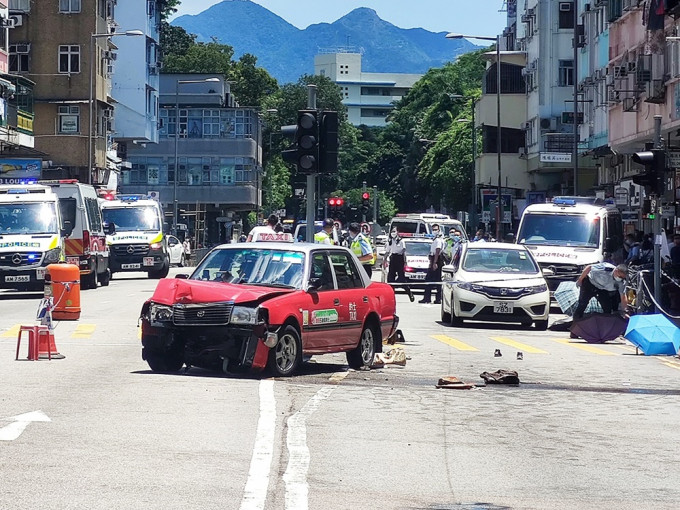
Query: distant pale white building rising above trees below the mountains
314 49 422 126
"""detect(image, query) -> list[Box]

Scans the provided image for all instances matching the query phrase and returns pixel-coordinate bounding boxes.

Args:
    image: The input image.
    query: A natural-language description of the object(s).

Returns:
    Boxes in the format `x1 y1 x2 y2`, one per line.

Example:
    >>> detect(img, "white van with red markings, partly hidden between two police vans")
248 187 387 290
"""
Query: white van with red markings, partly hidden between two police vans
39 179 112 289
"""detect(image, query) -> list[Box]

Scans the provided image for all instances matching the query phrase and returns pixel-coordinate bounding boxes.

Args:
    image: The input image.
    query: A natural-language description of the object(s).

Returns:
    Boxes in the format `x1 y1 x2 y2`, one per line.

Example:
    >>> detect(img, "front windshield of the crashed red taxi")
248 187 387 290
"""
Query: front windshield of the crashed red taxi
190 248 305 289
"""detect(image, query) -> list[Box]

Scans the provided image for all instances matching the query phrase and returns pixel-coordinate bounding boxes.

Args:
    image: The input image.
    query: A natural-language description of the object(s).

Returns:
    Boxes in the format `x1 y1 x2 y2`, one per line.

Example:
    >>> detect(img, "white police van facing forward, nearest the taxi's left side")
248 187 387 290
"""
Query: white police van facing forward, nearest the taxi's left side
101 195 170 278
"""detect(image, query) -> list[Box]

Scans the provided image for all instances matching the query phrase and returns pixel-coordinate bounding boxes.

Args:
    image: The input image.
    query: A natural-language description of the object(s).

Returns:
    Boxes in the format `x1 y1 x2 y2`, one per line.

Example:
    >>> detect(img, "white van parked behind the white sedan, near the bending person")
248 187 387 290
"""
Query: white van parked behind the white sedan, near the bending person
516 197 623 291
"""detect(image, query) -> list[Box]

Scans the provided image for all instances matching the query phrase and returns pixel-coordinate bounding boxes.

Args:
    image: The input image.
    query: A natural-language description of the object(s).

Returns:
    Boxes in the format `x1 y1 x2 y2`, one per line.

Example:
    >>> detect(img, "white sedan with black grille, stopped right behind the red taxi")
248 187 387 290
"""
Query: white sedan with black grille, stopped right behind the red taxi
441 242 550 330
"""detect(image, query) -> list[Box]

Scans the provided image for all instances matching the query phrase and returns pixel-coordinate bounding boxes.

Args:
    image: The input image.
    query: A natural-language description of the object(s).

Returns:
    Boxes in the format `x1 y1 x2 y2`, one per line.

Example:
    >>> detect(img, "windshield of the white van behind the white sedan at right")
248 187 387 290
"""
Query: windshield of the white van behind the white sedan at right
517 213 600 248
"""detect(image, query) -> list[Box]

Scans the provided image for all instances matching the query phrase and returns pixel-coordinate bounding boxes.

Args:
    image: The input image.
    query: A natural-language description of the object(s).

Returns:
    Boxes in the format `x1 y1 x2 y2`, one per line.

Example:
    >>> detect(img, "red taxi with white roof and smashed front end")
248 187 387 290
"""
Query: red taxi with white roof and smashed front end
141 234 398 376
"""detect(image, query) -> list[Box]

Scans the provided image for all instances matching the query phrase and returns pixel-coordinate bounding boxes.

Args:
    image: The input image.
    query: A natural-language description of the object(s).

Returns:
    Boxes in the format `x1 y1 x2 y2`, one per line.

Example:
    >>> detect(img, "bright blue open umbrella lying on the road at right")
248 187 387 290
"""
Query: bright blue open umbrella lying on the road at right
623 313 680 356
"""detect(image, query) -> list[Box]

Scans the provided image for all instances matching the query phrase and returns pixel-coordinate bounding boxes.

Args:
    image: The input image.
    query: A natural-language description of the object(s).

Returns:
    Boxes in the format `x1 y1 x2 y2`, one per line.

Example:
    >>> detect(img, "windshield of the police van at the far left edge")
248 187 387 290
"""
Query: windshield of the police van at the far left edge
0 202 57 234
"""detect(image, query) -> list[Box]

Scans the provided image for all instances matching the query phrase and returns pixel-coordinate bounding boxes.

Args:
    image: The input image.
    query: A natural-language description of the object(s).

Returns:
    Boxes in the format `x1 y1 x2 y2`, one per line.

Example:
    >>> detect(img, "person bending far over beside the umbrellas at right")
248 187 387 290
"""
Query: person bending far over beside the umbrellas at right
574 262 628 320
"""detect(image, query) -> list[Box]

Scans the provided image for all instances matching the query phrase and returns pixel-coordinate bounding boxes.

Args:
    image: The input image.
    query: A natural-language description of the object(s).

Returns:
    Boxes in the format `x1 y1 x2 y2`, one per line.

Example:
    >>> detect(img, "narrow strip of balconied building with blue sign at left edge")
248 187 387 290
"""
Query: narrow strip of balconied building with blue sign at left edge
0 0 36 184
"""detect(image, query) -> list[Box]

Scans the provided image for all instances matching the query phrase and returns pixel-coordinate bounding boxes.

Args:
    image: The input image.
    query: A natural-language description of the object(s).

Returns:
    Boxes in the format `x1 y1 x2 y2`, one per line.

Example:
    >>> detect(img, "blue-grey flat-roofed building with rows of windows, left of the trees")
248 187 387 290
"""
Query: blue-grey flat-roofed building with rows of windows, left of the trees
119 74 262 246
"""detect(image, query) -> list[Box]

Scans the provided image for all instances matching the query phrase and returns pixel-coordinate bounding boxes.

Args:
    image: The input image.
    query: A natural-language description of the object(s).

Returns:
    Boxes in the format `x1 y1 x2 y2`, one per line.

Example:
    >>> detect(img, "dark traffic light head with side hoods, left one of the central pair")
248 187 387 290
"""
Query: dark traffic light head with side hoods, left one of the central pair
281 110 319 174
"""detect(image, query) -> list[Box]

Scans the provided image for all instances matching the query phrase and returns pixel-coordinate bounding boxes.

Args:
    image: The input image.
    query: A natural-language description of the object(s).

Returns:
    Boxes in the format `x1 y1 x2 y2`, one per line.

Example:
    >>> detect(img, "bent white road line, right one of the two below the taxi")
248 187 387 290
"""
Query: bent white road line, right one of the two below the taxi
283 387 335 510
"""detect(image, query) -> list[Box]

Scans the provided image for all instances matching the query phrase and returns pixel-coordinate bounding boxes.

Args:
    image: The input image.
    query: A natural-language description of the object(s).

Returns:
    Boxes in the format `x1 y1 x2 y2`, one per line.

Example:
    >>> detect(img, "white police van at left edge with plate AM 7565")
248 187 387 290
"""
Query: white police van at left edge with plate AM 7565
0 184 65 290
